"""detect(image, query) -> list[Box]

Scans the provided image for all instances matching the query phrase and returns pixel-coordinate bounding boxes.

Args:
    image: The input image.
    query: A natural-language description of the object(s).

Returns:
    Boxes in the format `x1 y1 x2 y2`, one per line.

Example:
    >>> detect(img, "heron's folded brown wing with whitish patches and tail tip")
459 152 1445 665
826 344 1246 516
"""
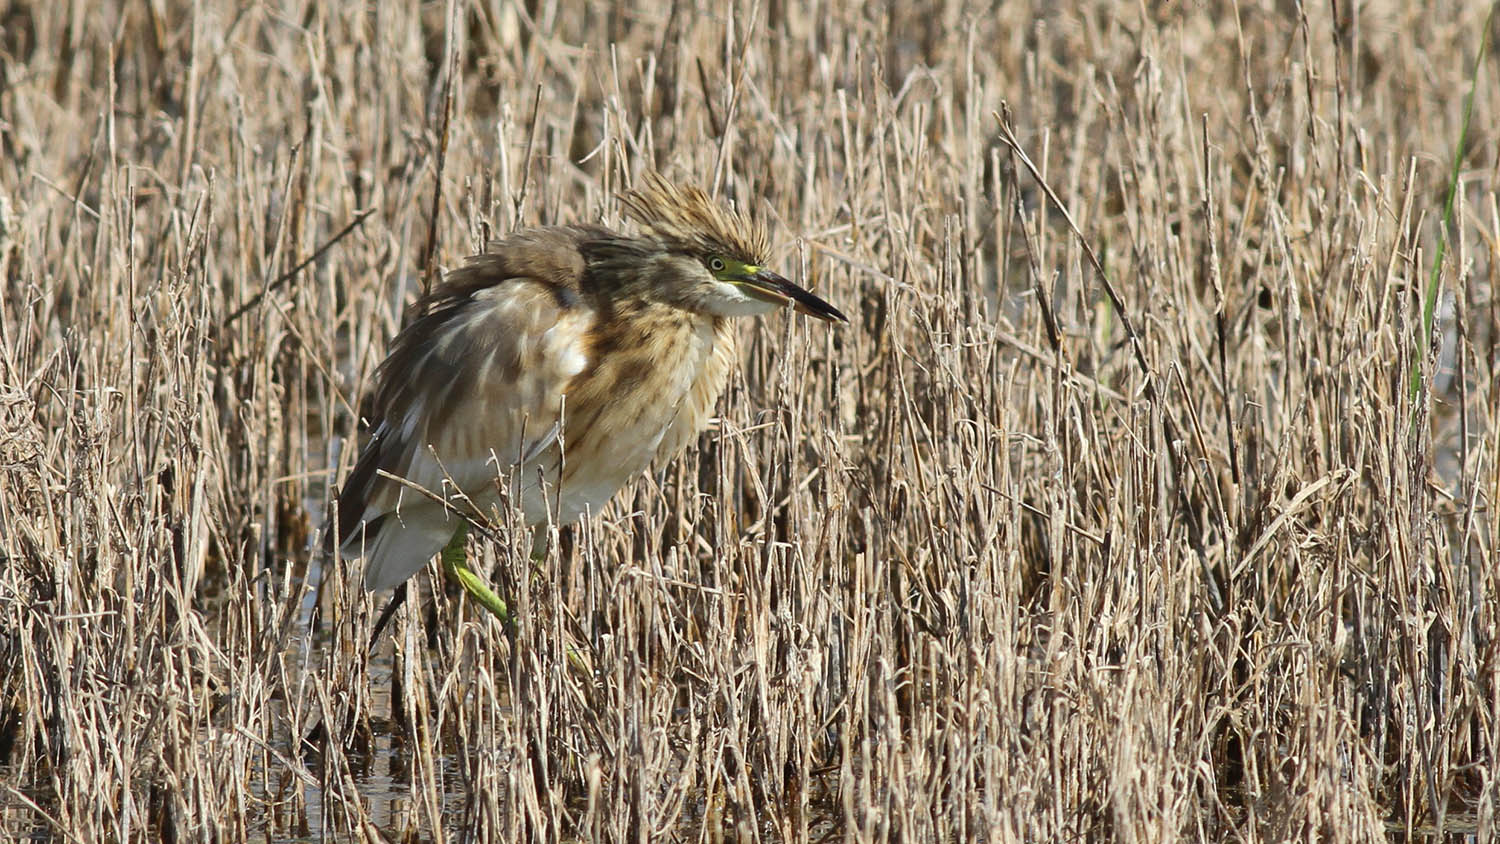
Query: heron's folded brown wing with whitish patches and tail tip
339 229 596 589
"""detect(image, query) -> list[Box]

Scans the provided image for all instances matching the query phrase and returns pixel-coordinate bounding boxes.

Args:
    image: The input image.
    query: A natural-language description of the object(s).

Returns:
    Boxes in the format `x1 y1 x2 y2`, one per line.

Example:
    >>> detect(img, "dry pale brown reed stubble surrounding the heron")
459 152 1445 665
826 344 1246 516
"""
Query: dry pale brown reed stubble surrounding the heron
0 0 1500 841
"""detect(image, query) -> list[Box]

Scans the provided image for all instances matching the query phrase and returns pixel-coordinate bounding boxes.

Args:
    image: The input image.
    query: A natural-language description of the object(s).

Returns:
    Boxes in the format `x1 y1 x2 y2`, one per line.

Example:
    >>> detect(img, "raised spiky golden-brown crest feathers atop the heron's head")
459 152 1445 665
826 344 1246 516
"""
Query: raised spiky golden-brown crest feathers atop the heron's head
620 171 771 264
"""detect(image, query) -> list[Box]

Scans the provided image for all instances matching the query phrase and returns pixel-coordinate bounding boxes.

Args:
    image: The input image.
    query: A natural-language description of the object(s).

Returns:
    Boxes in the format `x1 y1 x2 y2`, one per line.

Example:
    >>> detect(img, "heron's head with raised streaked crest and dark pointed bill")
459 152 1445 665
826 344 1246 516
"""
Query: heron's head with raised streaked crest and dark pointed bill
621 172 848 322
